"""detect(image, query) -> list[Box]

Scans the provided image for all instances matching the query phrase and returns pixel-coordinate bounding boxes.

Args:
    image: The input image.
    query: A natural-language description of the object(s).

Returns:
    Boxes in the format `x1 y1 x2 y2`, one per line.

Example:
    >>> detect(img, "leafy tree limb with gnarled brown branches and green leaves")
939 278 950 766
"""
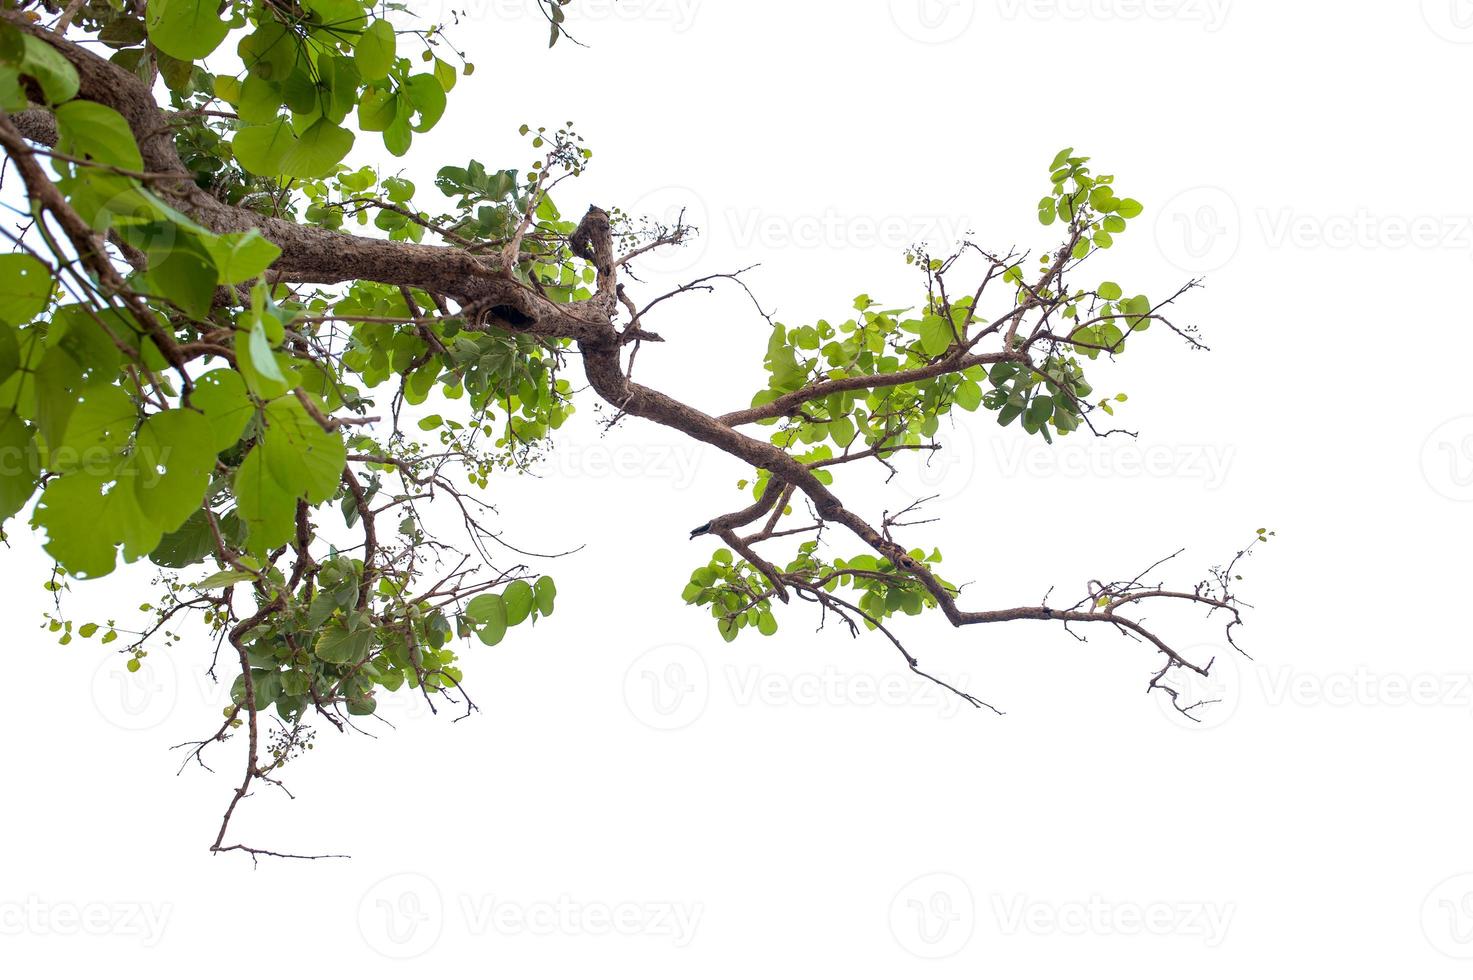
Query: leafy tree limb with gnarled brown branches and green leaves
0 0 1268 856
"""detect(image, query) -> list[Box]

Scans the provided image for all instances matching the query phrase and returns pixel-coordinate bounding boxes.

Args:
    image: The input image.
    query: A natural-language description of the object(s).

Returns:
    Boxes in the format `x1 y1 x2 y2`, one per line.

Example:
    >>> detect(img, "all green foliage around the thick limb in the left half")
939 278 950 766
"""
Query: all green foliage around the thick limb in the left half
0 0 592 718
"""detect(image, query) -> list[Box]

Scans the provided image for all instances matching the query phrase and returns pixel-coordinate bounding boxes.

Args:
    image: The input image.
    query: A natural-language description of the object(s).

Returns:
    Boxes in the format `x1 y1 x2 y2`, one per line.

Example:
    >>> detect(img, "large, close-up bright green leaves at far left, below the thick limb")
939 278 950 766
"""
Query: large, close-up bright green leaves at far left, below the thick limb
0 24 302 576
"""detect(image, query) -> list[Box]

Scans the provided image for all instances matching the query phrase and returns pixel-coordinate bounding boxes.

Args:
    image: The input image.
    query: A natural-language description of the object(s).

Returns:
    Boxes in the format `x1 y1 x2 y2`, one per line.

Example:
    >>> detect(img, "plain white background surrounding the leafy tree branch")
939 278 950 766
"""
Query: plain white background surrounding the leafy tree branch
0 0 1473 979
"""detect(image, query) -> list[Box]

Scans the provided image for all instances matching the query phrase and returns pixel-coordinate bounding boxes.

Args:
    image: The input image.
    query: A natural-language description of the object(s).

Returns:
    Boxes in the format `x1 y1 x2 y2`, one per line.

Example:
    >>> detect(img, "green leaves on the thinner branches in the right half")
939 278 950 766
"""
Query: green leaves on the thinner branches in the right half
683 147 1172 630
